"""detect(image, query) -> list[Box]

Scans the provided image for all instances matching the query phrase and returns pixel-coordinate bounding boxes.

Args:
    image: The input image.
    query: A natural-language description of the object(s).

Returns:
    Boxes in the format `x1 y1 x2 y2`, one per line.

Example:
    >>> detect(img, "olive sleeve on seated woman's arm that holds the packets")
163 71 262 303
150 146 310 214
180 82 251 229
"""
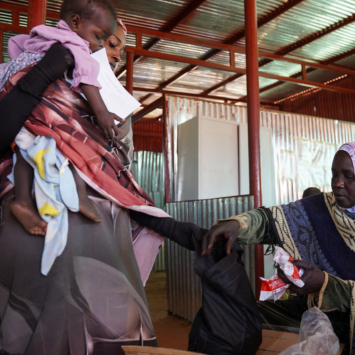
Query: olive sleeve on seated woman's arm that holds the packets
311 272 352 313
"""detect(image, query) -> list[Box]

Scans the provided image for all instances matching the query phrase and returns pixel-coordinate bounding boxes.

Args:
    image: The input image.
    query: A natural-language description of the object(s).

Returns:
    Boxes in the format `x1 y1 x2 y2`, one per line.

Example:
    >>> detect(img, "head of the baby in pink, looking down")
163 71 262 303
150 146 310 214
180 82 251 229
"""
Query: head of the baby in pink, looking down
60 0 117 52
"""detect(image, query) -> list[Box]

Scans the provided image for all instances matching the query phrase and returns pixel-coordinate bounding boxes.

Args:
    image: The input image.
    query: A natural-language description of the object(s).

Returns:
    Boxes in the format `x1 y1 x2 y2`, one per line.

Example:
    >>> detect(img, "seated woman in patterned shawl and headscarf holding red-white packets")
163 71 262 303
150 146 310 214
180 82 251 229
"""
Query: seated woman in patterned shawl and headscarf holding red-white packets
203 142 355 353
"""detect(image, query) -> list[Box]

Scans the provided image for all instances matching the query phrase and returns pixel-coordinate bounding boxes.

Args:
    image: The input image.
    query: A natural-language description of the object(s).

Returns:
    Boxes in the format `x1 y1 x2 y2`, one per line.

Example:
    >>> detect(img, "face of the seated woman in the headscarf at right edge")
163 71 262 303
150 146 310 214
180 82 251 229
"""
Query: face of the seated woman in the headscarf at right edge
332 150 355 208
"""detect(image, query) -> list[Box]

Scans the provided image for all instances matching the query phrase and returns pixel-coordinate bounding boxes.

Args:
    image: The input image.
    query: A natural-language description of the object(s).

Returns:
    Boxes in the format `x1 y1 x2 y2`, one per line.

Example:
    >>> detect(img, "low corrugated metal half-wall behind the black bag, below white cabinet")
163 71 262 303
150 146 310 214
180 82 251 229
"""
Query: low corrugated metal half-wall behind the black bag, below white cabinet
165 196 255 322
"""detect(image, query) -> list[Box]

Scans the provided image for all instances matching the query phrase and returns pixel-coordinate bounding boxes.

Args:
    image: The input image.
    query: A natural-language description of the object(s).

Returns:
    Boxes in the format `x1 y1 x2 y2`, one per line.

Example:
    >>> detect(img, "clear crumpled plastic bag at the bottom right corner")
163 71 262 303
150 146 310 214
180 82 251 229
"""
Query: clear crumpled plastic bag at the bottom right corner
279 307 339 355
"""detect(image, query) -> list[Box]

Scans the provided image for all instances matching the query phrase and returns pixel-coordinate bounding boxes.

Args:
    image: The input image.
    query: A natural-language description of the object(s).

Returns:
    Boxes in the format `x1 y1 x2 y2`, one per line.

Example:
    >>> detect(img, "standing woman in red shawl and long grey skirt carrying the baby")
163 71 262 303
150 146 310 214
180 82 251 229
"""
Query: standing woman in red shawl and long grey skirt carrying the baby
0 18 195 355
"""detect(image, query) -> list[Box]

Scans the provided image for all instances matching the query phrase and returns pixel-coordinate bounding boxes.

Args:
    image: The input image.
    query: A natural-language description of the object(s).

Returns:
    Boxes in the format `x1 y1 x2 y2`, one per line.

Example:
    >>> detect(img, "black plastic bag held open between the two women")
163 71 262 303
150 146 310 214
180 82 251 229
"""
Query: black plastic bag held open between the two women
188 240 262 355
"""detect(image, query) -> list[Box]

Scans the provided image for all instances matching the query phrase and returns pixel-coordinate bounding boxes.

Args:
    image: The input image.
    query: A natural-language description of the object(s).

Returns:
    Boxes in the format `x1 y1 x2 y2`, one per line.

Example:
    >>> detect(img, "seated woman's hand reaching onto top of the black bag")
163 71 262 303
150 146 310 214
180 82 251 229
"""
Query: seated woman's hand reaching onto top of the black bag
201 220 240 255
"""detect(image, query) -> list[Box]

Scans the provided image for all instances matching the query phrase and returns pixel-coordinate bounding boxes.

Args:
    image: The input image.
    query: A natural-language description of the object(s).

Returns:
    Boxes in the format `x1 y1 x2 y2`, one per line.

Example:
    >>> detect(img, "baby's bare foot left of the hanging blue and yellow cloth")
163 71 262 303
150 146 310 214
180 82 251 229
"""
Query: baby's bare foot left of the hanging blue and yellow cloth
11 201 47 236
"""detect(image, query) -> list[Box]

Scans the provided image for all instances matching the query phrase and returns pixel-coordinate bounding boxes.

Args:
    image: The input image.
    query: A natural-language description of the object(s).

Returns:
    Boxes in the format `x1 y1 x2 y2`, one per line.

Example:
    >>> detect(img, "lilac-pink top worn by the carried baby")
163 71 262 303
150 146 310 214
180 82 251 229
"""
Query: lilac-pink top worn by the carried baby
8 20 101 93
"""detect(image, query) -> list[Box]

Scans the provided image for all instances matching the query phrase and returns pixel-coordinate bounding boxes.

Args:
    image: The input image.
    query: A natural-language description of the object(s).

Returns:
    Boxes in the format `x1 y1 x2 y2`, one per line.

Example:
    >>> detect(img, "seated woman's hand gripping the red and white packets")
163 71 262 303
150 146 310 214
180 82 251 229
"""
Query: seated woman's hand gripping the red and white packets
277 260 325 296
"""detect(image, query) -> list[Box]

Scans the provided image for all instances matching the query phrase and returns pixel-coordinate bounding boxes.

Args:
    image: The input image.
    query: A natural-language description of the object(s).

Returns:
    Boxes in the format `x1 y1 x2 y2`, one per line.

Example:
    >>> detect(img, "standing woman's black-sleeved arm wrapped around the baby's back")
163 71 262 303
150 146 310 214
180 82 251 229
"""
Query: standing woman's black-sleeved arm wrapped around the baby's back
0 43 74 157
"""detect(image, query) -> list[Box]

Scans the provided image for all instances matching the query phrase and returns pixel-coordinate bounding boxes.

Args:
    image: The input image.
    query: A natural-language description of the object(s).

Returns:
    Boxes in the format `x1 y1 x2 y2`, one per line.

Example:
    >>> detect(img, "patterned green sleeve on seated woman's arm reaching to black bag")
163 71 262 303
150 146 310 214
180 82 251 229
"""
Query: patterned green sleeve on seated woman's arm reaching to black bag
216 208 276 244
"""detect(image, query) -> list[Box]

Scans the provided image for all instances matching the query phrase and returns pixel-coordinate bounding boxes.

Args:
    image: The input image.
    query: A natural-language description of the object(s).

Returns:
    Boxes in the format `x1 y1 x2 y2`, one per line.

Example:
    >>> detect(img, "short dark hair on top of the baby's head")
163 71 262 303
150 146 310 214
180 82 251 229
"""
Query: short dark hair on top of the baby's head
60 0 117 21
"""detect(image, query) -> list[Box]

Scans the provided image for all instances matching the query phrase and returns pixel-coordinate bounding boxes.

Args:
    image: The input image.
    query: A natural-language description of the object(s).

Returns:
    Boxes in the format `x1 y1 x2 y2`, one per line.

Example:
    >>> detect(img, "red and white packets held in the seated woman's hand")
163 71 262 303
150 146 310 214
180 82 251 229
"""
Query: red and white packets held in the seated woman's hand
259 247 304 301
